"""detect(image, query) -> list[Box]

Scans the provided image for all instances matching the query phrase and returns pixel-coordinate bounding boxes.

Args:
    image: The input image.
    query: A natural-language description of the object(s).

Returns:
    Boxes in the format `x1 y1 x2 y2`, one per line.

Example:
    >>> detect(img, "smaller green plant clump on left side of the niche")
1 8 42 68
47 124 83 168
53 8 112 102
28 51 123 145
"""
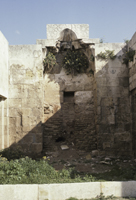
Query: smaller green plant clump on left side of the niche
43 52 56 73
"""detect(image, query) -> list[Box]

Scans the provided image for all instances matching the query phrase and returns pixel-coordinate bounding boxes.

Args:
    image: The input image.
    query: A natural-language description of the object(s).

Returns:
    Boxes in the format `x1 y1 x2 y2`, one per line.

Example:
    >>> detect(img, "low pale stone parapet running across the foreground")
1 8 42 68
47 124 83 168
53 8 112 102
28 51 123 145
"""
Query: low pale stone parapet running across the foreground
0 181 136 200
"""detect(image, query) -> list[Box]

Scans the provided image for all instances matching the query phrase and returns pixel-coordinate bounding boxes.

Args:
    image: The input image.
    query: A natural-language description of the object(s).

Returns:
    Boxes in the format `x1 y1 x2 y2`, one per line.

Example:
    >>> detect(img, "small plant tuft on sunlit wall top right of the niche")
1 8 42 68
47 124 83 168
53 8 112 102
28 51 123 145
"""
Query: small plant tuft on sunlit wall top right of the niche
97 50 116 60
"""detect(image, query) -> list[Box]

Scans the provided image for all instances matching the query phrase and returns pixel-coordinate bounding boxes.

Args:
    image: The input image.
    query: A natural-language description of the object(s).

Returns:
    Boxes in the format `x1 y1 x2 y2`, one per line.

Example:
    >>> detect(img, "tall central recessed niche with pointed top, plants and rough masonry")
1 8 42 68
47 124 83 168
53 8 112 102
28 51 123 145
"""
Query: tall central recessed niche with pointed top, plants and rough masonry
43 28 96 151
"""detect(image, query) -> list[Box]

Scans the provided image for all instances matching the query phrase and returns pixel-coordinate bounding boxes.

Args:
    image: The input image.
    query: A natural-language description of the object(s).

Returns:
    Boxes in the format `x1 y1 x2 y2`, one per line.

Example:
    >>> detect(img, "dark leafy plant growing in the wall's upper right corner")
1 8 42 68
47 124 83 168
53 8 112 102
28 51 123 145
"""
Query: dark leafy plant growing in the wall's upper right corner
123 48 135 65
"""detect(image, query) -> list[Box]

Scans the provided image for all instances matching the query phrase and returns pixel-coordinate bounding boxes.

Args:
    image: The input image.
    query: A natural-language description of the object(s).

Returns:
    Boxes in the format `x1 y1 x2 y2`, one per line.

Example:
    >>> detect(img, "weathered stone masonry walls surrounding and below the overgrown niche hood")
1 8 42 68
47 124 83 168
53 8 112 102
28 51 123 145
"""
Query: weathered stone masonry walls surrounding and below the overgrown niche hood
0 24 136 156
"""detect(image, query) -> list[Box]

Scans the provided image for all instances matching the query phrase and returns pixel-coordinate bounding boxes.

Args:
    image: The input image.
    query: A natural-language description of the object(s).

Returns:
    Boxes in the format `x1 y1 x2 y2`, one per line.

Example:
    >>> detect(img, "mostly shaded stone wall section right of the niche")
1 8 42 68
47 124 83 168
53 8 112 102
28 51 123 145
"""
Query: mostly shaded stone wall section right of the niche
95 44 132 156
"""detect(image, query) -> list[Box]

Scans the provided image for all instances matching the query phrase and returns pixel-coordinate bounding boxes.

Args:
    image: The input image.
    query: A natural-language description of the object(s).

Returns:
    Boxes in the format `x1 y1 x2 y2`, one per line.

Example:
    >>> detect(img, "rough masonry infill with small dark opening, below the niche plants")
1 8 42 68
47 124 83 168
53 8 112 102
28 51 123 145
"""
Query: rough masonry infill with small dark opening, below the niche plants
43 69 96 151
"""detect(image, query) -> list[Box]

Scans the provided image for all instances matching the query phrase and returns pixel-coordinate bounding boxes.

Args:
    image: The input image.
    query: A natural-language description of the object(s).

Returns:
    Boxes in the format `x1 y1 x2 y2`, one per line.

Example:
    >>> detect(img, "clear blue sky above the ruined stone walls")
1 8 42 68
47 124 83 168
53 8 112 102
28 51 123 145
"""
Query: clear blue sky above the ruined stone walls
0 0 136 45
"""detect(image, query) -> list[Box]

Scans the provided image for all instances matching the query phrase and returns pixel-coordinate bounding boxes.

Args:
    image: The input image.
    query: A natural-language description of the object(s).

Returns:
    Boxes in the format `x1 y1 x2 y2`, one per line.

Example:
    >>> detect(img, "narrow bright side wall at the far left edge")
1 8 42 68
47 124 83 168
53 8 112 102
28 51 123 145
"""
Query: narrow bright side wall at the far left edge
0 32 9 149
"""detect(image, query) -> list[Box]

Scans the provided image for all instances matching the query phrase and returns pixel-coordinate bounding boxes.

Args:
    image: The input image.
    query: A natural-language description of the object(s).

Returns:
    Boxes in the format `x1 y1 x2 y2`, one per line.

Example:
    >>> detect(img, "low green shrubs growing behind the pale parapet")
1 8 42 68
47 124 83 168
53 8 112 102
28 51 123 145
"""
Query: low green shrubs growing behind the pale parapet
0 157 95 184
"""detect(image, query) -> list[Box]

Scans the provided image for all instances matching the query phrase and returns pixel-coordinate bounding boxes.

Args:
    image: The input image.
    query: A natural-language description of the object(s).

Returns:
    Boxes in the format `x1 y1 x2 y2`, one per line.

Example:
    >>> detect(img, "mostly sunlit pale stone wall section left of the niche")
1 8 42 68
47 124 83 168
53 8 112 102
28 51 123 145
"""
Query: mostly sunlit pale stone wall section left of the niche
8 45 43 153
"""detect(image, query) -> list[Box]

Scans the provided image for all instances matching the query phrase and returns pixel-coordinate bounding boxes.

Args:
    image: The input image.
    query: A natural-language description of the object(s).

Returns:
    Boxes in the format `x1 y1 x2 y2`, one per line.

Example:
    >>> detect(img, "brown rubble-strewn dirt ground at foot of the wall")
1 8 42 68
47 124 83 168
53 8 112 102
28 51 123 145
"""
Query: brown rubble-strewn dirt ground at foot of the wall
43 145 136 174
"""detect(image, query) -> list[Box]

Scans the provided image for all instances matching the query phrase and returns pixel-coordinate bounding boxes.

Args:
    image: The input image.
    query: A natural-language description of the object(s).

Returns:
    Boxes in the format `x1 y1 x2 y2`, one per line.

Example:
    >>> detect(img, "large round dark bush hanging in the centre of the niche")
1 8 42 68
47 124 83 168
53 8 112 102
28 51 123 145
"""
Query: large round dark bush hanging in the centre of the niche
63 50 89 75
